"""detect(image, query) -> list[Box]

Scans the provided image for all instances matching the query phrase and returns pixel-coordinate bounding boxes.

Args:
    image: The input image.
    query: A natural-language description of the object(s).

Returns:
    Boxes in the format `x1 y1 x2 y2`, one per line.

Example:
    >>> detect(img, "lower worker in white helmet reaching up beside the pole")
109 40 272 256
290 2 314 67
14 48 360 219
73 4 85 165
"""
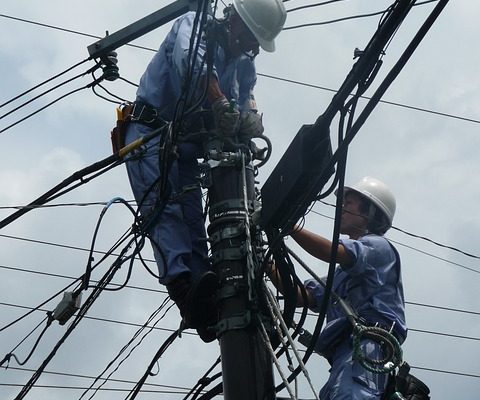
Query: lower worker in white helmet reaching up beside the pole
269 177 407 400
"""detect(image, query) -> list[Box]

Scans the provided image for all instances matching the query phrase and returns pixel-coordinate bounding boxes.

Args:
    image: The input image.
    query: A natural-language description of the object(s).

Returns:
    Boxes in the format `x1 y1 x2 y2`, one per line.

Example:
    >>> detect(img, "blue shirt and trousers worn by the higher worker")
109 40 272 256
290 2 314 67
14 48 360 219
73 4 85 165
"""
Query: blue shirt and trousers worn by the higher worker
126 12 256 284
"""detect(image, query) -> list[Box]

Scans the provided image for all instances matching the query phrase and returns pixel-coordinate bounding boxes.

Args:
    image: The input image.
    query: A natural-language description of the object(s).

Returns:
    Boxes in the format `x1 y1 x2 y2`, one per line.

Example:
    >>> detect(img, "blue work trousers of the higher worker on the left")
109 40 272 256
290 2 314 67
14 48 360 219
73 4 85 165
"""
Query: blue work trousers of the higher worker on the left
125 123 209 285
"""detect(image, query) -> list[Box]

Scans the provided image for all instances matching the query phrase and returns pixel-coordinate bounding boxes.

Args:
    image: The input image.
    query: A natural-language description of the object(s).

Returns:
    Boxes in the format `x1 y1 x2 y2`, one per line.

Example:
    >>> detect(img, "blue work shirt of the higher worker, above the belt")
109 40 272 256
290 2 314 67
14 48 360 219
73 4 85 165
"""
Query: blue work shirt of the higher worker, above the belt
137 11 257 120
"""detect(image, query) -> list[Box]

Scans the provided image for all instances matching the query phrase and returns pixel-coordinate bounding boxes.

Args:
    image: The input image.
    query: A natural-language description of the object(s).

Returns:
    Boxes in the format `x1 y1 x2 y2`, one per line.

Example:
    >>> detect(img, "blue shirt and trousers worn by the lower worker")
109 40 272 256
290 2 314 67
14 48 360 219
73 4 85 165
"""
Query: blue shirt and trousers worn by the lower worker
305 235 407 400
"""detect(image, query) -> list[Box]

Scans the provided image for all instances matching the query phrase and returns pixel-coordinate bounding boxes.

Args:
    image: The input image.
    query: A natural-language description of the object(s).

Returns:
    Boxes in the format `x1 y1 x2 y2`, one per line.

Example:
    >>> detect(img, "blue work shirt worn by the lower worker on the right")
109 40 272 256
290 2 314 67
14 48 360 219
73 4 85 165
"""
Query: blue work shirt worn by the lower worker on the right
305 234 407 354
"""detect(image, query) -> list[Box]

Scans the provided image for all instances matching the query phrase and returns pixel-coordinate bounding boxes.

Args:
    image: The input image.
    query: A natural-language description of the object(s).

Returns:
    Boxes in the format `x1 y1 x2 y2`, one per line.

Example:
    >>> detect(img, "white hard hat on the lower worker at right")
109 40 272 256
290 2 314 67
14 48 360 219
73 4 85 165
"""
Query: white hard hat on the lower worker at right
344 176 396 225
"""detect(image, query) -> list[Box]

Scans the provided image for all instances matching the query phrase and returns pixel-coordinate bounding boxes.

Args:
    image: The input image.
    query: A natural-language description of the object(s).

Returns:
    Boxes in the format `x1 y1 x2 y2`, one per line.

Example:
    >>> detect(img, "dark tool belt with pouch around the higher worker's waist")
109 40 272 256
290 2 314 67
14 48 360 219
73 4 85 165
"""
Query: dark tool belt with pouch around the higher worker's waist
110 101 167 154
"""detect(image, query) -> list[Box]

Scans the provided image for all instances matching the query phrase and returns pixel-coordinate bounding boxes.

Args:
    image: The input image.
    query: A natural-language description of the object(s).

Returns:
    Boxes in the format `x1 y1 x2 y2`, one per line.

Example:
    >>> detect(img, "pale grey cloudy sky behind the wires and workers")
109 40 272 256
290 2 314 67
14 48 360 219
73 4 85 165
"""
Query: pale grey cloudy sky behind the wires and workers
0 0 480 400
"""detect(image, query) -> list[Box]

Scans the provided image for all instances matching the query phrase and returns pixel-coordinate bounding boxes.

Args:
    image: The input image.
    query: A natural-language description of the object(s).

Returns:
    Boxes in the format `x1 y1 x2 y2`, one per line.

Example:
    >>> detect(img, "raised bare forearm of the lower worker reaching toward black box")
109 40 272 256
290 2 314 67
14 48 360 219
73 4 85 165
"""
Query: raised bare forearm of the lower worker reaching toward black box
291 228 353 266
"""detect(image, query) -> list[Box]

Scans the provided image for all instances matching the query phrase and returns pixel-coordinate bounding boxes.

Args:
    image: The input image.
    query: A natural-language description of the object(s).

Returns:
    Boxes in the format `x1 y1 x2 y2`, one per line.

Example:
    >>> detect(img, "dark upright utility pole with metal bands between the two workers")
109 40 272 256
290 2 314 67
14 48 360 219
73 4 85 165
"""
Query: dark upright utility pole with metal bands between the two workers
207 140 275 400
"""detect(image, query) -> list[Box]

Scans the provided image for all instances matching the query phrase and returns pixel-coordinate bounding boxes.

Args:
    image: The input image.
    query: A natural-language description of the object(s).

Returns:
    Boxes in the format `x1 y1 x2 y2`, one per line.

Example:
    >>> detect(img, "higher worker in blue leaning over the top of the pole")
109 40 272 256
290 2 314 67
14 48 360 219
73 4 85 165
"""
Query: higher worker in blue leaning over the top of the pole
125 0 286 342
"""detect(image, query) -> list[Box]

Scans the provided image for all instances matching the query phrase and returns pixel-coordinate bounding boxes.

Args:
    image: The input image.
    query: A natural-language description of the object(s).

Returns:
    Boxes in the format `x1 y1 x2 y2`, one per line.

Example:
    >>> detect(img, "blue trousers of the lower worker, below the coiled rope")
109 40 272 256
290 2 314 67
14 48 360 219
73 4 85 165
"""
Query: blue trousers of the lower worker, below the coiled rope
320 337 388 400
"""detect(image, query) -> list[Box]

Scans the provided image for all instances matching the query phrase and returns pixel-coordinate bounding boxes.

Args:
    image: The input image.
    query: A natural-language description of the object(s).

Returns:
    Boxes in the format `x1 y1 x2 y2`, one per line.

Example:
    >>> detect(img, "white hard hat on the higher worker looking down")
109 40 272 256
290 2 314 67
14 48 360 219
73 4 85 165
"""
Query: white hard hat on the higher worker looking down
233 0 287 53
